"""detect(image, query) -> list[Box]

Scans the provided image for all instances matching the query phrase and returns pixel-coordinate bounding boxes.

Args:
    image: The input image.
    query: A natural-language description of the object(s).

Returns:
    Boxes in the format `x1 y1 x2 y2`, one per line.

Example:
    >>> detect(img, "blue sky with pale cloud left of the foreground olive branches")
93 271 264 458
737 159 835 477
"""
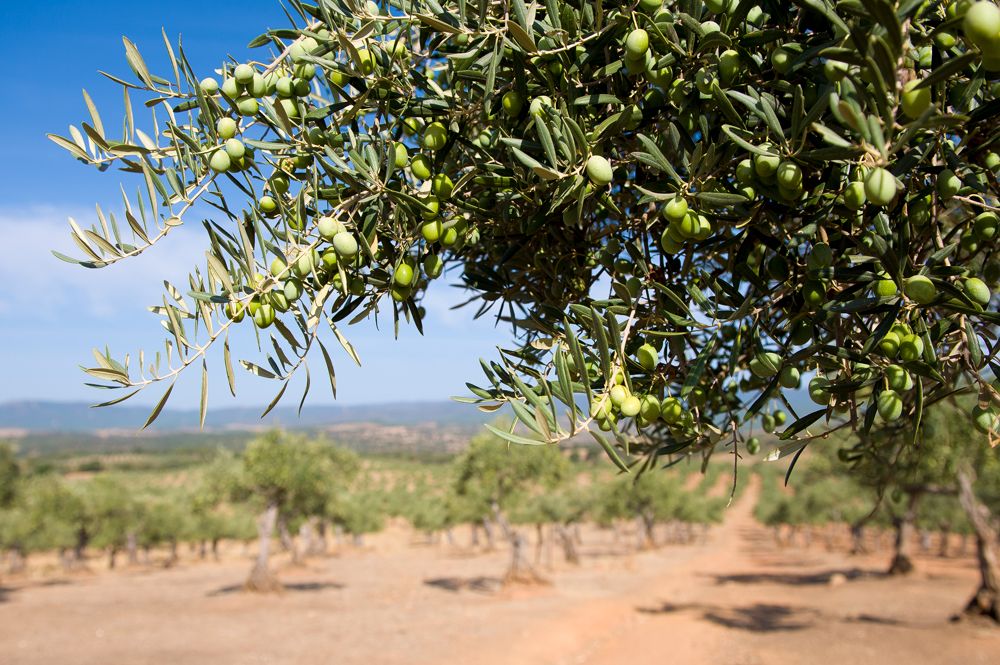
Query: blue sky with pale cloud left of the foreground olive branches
0 0 506 407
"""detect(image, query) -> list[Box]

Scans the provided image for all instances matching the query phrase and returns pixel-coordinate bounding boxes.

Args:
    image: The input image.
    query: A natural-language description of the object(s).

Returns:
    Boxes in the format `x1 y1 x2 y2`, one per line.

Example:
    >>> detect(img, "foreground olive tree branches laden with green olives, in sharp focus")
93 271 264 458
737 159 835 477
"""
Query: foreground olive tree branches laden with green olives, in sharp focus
52 0 1000 608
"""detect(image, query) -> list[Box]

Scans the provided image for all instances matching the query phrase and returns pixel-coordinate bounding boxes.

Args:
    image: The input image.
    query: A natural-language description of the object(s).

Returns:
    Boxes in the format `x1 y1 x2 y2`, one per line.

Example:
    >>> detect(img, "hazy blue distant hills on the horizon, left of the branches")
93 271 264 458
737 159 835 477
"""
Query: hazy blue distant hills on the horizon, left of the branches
0 401 490 436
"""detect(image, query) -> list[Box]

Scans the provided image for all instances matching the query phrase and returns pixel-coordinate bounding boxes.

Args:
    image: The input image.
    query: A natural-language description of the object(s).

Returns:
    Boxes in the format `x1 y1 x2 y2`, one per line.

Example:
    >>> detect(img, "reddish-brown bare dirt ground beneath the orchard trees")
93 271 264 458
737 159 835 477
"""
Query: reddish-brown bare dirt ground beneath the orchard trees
0 478 1000 665
